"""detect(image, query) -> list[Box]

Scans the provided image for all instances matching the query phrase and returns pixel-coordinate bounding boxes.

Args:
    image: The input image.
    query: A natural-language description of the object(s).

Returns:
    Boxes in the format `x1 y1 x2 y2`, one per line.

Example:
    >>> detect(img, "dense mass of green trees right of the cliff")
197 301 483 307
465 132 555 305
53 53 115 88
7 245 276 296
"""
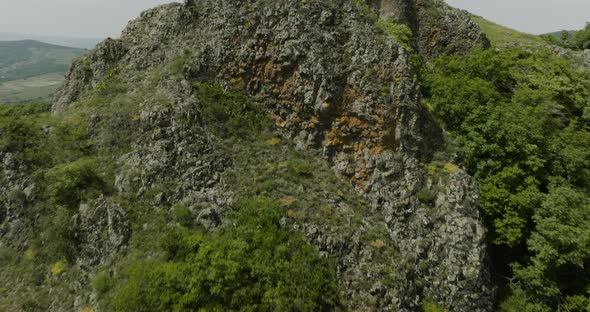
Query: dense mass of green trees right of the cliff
424 48 590 311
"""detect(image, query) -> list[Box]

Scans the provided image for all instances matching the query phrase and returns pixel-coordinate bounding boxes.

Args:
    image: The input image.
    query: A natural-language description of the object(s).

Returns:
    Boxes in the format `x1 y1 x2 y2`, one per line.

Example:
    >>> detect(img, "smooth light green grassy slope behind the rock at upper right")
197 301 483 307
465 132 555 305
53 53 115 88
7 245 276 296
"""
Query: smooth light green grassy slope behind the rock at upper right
472 15 546 46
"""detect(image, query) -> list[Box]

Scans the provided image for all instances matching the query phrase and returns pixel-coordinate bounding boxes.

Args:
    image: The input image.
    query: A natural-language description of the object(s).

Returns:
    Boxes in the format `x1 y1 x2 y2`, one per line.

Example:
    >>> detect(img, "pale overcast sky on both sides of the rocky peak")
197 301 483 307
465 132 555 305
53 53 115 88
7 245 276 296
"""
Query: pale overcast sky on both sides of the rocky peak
0 0 590 38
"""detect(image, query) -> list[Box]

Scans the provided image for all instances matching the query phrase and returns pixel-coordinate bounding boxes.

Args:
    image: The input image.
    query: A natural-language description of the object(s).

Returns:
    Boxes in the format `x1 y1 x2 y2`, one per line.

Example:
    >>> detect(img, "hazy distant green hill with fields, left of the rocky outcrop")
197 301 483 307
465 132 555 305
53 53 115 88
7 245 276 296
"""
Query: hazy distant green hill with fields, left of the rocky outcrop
0 40 85 103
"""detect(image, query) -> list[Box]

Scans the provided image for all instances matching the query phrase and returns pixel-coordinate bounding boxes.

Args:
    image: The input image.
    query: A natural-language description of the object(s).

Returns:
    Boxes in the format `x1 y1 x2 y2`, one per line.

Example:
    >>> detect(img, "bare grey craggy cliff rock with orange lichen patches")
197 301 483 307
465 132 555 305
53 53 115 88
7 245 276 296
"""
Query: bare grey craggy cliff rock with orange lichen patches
49 0 492 311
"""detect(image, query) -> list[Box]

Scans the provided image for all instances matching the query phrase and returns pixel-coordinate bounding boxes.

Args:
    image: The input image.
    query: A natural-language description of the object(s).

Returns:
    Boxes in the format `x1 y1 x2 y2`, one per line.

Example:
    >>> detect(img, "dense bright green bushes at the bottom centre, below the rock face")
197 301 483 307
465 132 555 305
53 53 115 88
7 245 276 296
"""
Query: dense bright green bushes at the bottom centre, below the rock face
95 198 337 311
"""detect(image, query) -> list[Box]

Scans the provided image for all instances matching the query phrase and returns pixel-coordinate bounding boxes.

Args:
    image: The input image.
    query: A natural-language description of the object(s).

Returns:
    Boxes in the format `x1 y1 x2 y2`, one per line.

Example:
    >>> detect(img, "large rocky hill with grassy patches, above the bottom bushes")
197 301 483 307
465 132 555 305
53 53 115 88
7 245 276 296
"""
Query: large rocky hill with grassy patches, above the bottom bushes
0 0 493 311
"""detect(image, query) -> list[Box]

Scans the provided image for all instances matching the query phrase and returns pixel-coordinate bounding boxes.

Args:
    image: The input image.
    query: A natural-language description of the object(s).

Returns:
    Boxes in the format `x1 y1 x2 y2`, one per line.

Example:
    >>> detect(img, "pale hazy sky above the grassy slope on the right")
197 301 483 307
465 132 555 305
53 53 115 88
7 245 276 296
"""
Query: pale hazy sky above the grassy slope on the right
446 0 590 34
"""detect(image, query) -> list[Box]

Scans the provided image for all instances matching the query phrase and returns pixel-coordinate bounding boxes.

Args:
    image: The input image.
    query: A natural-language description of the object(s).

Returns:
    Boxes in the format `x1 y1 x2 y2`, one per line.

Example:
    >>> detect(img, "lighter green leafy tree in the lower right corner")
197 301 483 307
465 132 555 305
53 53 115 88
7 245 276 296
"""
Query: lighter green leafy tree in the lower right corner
514 186 590 311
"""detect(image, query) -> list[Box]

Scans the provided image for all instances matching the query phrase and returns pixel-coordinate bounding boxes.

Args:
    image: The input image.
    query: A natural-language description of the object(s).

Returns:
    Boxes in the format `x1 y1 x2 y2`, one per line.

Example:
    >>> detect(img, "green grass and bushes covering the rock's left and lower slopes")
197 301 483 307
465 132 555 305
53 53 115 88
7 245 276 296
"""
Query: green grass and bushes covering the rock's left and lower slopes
0 69 370 311
